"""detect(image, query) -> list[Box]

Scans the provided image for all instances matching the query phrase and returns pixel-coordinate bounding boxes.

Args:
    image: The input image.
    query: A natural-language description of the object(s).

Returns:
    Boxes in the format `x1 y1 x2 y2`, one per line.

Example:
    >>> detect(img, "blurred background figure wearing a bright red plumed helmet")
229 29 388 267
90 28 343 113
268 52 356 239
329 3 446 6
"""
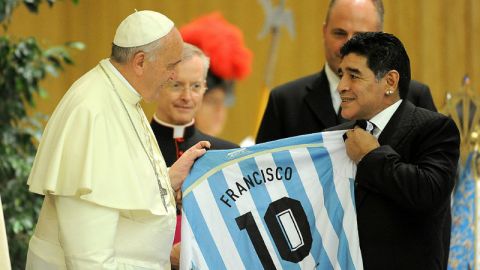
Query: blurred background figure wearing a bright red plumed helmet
180 12 252 136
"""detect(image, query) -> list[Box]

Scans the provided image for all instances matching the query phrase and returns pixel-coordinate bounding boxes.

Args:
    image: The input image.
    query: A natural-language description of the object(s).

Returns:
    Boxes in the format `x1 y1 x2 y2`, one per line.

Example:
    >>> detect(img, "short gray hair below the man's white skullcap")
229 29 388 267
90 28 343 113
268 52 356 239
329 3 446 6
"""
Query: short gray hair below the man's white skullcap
110 38 163 64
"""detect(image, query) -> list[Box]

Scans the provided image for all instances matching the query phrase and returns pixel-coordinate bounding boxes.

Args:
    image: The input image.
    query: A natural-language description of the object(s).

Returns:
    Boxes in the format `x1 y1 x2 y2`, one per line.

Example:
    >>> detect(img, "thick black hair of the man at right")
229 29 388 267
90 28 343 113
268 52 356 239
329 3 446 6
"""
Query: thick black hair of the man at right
340 32 410 99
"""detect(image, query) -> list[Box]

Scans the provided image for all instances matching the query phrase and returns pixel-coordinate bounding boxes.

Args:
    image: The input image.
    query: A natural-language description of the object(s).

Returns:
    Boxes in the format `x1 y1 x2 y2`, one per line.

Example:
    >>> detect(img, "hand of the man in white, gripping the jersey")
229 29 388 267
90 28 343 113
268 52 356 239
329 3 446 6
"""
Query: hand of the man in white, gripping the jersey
168 141 210 191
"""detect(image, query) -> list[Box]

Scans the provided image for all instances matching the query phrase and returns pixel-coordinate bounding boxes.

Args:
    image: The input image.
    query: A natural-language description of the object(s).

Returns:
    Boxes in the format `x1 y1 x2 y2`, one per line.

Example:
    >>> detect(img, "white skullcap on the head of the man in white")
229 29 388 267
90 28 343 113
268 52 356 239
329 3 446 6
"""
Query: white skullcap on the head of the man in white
113 10 174 48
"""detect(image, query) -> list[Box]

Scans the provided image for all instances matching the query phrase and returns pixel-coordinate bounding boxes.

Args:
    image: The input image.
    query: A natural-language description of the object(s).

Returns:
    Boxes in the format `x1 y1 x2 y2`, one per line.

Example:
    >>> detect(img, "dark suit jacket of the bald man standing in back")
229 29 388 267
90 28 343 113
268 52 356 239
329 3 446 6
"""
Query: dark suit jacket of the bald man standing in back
256 70 436 143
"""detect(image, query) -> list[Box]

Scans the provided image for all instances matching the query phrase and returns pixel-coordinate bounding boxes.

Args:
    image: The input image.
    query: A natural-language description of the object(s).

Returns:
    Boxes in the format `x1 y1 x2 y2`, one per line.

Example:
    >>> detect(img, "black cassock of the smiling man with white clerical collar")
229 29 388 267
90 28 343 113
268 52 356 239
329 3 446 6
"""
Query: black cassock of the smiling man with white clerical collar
150 120 239 167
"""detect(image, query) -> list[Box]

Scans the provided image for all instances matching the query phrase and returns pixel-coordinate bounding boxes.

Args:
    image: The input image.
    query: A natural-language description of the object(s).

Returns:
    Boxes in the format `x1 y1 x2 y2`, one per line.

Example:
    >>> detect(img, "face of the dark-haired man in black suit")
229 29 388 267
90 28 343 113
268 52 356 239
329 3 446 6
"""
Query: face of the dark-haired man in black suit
337 53 390 120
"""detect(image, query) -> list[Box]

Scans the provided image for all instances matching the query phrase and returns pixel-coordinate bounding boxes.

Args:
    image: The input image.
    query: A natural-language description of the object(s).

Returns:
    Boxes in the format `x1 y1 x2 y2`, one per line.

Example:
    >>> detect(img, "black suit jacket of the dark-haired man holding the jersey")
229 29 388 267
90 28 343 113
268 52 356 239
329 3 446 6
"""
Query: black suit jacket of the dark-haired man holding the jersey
329 101 460 270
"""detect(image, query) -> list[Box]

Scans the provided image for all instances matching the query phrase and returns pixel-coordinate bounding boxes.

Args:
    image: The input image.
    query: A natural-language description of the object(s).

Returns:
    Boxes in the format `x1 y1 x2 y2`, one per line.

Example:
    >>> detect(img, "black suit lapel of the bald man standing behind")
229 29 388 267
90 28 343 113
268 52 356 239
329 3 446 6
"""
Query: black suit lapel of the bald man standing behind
305 70 337 127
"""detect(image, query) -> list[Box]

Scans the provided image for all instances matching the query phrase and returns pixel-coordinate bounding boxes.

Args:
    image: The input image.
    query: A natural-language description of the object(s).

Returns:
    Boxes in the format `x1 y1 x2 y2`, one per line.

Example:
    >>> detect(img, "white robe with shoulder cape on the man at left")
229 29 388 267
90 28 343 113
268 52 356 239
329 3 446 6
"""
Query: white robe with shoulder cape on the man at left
27 59 175 269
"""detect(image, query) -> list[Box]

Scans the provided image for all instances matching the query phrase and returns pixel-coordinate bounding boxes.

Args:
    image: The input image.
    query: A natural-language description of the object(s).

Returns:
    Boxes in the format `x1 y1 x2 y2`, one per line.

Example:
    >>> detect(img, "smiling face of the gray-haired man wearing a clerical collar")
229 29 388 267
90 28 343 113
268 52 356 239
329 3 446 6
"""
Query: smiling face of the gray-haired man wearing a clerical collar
156 55 206 125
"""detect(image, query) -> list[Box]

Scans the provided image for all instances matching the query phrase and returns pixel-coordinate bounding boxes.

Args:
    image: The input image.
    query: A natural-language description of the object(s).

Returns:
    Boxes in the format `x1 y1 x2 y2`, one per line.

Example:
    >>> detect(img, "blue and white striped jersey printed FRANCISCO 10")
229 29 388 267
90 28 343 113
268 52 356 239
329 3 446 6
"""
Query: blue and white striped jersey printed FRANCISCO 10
180 131 363 269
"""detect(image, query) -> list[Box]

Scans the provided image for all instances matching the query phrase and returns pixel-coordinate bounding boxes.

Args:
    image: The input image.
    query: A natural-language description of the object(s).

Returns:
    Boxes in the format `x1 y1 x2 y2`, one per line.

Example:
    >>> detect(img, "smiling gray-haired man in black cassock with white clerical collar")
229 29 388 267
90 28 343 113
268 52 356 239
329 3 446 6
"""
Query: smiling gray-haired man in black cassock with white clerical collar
150 43 238 269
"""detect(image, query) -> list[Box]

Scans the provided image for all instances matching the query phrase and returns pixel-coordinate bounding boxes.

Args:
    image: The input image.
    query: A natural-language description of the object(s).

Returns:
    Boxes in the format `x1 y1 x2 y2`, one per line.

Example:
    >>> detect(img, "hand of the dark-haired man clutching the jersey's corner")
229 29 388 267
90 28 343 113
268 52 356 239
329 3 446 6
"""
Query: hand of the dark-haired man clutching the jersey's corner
345 126 380 164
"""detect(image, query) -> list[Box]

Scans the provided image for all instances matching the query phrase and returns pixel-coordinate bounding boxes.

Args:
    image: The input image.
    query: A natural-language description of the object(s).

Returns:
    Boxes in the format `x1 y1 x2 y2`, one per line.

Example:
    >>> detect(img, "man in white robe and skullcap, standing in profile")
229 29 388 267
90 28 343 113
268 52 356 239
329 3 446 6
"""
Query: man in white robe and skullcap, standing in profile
23 11 210 269
